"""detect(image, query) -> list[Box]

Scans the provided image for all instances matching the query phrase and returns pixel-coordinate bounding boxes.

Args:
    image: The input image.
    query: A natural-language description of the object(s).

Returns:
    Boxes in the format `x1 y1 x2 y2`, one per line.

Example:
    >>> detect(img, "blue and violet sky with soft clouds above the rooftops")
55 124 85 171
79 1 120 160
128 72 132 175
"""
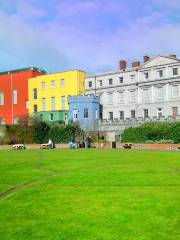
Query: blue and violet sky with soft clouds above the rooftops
0 0 180 73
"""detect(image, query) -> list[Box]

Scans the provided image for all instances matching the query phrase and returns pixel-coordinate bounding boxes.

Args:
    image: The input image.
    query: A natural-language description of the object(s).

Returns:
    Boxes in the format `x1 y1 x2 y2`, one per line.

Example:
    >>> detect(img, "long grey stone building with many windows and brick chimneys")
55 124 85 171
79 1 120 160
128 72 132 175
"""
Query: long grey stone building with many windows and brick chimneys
85 55 180 141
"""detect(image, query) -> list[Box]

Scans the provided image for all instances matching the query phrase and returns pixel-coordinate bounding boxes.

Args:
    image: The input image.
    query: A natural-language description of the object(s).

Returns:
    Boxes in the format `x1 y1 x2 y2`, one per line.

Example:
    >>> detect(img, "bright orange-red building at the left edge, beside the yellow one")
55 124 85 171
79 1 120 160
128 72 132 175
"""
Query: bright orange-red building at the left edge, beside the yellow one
0 68 45 125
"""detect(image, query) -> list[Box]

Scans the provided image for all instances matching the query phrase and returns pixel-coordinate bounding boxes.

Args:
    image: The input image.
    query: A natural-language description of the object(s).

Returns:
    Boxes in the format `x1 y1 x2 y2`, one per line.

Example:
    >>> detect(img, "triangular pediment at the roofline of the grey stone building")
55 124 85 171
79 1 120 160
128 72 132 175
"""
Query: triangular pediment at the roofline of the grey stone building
142 56 179 68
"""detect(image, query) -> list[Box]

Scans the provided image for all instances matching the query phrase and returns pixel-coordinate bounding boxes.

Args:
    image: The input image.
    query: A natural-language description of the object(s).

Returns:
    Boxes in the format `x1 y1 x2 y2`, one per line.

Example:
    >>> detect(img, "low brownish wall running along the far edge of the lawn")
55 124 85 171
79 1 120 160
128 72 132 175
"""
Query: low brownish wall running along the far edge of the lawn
0 143 180 150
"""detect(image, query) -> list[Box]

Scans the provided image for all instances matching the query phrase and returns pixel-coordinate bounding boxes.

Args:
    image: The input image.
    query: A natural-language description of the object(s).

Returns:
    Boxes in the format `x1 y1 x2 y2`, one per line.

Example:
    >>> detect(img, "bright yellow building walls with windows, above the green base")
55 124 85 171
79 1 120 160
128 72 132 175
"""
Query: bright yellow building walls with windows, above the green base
28 70 85 116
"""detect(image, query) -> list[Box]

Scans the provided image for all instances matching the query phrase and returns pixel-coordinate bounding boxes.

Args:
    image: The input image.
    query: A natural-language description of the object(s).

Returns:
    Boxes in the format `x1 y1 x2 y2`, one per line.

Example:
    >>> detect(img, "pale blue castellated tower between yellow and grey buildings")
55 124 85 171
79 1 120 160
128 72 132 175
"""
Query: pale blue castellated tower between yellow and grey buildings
68 95 100 131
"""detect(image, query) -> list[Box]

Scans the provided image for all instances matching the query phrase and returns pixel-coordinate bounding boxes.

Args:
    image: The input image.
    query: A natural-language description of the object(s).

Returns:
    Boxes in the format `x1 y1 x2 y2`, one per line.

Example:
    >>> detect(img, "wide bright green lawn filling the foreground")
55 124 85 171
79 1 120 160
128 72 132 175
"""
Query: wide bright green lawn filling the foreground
0 149 180 240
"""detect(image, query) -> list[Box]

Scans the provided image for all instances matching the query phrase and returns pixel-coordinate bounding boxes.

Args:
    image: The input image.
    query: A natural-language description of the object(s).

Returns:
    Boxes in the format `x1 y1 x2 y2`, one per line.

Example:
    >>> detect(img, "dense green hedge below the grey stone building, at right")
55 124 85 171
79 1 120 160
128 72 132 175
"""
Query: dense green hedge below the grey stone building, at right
121 121 180 143
